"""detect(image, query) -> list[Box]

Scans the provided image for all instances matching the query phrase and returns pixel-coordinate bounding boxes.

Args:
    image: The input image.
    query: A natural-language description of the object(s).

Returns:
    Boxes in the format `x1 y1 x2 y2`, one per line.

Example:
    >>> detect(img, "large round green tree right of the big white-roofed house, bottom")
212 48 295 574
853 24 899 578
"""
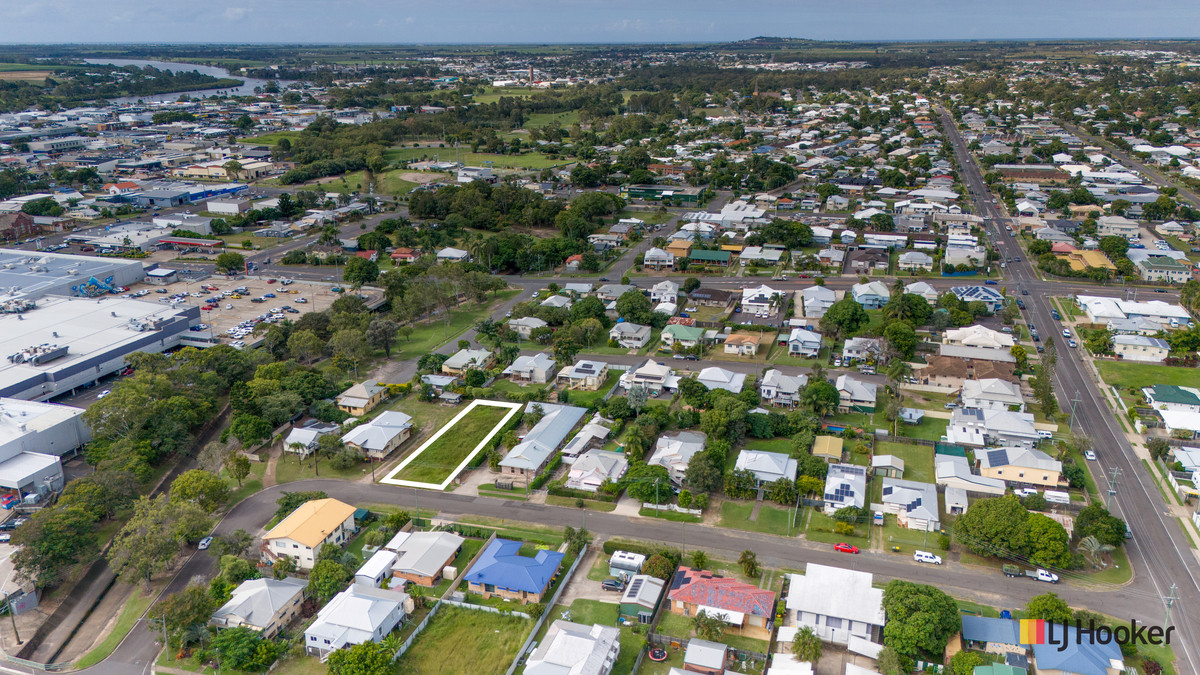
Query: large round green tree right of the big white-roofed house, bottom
883 578 973 658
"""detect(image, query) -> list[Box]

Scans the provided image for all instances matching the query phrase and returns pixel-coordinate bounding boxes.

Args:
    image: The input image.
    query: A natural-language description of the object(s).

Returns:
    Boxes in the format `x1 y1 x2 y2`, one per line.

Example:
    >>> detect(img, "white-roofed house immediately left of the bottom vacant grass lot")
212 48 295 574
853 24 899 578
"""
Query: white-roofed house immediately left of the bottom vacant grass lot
304 584 408 657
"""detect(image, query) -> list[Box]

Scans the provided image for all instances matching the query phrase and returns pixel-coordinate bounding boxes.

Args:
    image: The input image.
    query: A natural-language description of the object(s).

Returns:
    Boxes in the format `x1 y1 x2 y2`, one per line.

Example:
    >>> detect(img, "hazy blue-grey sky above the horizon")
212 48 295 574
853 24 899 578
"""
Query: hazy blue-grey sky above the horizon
0 0 1200 44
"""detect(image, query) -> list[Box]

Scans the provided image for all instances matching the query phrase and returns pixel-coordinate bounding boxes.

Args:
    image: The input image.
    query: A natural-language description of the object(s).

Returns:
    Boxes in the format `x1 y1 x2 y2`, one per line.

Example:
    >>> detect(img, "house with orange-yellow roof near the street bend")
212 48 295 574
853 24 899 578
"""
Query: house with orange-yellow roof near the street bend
262 498 358 569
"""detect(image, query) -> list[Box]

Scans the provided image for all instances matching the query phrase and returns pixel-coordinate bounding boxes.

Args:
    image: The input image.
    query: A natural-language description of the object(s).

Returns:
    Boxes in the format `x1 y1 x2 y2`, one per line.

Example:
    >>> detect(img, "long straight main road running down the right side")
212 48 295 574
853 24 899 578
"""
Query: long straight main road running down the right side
942 110 1200 673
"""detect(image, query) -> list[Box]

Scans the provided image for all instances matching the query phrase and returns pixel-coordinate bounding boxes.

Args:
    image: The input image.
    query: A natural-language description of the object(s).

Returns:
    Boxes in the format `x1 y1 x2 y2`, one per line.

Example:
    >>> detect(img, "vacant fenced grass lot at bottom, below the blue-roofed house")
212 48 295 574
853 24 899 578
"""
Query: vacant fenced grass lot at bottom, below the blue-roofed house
396 607 533 675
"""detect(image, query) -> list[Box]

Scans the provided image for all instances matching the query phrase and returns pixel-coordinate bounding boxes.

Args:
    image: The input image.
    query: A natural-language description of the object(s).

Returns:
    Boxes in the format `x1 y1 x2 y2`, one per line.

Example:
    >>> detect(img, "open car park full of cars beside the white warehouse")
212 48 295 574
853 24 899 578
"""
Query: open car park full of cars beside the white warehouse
123 276 350 347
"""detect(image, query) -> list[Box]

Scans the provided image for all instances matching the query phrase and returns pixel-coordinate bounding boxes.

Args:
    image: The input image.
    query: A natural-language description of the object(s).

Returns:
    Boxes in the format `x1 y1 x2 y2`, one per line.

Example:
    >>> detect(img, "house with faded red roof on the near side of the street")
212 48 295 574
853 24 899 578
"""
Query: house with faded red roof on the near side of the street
667 566 775 640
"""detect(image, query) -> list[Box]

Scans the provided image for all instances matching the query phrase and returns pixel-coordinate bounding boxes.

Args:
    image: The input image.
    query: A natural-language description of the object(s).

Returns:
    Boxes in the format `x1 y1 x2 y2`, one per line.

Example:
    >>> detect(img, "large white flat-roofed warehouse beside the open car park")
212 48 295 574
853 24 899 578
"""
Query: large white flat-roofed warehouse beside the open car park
0 294 200 401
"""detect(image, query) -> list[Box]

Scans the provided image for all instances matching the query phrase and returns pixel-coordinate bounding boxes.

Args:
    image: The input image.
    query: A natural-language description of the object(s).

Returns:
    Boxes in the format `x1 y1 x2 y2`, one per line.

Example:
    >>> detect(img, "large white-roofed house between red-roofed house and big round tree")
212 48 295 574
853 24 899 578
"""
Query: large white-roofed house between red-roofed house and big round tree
785 562 884 645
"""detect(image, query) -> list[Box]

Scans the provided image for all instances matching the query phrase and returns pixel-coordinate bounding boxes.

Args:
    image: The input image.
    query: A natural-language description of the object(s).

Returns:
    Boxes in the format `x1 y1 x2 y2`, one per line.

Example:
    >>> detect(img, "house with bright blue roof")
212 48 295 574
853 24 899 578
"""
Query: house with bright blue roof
467 539 563 604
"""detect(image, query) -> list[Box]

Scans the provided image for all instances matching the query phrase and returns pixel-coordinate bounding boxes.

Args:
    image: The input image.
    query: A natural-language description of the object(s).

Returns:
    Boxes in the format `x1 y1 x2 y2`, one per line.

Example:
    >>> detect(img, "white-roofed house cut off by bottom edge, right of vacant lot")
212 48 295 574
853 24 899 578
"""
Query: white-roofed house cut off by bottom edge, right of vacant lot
524 619 620 675
